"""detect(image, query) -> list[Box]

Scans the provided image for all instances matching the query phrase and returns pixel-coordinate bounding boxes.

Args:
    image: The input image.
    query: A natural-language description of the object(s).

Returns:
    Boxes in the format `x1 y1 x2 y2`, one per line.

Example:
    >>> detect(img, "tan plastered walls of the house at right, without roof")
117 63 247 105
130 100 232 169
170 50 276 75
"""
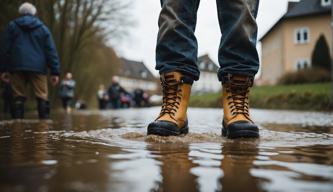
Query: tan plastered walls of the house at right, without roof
260 14 332 84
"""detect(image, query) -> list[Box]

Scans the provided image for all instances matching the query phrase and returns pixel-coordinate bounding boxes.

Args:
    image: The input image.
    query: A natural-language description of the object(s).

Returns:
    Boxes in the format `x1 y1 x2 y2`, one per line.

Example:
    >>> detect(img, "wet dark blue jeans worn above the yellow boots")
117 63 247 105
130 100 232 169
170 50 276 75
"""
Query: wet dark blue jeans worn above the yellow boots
156 0 259 81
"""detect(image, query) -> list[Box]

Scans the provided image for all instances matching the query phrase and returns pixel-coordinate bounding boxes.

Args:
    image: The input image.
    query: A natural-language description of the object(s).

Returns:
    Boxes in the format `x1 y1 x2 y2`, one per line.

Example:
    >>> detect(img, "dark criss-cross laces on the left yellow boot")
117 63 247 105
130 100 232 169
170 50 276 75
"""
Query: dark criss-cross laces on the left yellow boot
157 75 182 121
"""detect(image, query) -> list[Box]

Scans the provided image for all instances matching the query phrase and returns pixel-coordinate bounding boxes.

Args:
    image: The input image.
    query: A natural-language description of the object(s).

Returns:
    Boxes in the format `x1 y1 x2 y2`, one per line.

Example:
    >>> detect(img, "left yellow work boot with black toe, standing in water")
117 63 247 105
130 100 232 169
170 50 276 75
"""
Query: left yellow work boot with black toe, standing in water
148 72 193 136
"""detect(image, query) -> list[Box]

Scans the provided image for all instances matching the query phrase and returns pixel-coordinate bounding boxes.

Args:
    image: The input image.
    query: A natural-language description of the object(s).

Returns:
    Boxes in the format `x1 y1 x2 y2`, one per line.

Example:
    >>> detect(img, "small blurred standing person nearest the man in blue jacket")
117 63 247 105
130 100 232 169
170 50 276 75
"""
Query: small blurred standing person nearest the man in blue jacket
60 73 76 113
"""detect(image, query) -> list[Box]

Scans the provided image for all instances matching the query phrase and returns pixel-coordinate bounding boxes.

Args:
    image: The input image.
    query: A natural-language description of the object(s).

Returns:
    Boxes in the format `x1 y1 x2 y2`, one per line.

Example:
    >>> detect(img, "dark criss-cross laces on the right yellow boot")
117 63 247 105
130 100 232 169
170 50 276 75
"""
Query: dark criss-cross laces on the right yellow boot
227 82 250 117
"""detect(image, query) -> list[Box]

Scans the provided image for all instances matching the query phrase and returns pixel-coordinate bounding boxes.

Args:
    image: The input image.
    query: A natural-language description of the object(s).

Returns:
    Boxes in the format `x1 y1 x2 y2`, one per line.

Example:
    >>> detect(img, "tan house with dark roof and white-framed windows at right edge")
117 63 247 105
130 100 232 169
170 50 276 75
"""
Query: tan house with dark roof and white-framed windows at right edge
259 0 332 84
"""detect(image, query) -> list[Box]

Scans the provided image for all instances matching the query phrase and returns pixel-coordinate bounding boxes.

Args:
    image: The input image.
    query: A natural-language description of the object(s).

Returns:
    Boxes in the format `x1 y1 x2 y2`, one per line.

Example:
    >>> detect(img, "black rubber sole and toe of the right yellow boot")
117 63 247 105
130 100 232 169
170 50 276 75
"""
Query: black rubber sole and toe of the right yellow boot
222 121 259 139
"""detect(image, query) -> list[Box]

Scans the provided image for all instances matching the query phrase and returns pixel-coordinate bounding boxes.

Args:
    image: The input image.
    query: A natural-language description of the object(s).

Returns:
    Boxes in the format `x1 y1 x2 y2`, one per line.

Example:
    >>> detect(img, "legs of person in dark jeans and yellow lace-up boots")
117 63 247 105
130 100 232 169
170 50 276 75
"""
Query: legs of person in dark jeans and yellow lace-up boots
147 0 259 138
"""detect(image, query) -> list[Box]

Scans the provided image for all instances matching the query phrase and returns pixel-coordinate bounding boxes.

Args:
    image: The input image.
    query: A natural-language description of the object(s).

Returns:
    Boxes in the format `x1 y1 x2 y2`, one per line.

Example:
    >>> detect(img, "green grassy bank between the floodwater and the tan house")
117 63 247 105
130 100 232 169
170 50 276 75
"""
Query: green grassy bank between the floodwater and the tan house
190 83 331 111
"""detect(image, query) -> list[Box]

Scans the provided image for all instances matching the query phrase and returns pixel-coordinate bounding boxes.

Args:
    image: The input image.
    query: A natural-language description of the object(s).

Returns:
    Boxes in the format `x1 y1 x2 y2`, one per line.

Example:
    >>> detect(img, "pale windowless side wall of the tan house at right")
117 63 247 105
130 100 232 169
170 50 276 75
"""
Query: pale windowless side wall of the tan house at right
260 23 284 84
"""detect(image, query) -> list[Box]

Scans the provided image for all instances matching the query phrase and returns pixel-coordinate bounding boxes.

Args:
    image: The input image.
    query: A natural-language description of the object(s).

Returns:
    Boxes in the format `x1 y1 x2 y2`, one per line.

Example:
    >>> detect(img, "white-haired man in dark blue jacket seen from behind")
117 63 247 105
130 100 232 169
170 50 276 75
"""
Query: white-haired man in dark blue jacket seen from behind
0 3 60 119
